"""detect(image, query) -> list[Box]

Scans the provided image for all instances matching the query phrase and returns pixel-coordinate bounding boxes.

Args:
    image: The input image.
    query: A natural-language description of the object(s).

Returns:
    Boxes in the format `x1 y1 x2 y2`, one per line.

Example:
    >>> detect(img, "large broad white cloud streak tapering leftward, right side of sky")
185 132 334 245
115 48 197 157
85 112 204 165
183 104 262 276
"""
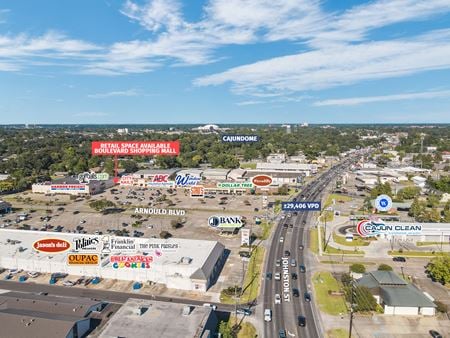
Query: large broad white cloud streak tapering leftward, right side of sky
194 29 450 95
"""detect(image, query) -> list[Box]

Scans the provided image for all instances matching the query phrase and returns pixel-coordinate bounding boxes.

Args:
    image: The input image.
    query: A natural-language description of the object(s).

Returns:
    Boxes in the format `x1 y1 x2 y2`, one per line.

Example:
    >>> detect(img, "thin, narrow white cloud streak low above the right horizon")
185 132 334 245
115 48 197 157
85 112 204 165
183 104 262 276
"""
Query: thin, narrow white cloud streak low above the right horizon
313 90 450 107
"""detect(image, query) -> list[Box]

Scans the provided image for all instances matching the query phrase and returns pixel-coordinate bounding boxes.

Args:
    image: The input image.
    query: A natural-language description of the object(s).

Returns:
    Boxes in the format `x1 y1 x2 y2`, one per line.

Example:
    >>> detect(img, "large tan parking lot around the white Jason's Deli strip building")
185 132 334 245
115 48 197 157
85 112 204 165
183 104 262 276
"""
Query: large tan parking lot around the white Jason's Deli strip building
0 187 296 300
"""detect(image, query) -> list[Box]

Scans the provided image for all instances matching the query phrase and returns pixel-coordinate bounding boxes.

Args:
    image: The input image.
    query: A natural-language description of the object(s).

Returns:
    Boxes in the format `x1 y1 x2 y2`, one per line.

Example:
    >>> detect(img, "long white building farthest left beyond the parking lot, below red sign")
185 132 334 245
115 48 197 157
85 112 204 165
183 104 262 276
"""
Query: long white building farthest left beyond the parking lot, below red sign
31 177 114 196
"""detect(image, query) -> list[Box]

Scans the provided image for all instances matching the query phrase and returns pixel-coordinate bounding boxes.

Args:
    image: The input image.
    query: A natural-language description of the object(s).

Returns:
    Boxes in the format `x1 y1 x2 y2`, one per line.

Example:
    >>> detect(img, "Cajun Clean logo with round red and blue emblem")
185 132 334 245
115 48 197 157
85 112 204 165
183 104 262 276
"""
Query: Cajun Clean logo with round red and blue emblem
356 220 422 237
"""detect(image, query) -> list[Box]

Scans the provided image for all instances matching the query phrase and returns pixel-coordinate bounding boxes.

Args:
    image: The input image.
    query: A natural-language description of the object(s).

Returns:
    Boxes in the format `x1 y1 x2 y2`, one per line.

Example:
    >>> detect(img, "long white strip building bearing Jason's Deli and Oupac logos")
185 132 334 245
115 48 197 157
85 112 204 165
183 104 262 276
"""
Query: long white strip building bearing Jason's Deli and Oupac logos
0 229 226 291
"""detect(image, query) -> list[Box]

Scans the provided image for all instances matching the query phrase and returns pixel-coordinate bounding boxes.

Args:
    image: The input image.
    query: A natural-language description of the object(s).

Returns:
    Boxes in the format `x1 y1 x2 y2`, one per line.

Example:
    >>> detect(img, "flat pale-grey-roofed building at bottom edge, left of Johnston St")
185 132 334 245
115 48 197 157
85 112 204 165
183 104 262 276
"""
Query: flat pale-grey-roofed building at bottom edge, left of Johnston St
98 298 218 338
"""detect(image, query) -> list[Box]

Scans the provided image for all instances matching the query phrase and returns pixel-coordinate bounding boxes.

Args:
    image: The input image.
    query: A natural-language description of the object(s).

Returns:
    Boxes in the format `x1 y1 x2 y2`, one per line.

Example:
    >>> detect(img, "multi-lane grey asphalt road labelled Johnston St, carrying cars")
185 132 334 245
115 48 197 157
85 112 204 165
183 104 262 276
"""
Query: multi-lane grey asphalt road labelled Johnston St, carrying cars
262 160 352 338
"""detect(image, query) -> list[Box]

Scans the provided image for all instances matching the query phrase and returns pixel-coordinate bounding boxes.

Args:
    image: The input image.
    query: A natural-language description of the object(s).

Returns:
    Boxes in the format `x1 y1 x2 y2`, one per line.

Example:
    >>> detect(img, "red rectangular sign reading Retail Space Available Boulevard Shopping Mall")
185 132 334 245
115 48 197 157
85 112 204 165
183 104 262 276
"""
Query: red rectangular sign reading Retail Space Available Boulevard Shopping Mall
91 141 180 156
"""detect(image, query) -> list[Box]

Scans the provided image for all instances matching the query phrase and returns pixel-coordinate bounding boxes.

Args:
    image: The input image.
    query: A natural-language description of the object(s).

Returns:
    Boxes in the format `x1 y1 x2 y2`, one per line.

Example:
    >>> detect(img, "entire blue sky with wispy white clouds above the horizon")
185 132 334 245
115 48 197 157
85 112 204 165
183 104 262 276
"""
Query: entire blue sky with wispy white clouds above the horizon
0 0 450 124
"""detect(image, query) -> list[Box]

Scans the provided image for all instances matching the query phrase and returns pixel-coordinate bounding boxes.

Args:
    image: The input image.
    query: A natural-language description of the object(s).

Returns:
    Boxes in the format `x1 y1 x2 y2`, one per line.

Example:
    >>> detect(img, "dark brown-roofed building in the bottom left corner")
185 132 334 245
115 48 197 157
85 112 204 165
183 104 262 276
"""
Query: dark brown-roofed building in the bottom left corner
0 292 103 338
